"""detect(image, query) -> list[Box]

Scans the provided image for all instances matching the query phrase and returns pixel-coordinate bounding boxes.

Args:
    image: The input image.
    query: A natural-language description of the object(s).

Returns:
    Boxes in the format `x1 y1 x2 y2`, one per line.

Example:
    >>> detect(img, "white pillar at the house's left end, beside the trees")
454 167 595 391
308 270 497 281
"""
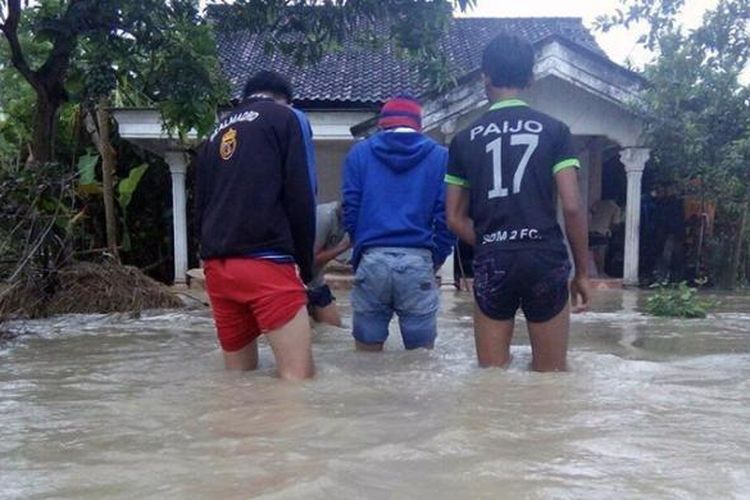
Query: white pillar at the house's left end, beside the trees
164 151 188 285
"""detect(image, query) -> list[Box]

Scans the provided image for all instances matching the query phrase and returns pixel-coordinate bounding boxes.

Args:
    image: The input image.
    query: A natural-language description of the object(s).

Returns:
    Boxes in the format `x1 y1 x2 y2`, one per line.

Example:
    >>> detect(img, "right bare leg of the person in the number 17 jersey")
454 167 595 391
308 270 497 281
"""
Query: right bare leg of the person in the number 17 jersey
528 305 570 372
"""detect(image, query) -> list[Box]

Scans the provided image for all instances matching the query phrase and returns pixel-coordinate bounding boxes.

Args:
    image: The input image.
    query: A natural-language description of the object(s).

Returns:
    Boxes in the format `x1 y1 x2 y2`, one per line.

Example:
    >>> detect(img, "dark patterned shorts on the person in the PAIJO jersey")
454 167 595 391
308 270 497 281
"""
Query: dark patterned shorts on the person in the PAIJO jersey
474 250 571 323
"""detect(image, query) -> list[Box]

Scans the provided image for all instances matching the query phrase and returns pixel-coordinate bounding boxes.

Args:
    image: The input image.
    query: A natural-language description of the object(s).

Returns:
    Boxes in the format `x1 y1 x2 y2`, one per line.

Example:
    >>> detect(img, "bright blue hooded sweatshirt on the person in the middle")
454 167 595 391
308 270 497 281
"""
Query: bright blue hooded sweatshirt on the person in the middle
342 132 455 268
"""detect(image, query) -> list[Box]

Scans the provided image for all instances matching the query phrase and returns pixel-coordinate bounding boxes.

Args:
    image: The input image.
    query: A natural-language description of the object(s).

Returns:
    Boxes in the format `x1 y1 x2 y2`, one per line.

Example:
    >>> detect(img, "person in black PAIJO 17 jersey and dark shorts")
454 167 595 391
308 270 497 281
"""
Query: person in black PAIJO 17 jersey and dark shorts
445 34 590 371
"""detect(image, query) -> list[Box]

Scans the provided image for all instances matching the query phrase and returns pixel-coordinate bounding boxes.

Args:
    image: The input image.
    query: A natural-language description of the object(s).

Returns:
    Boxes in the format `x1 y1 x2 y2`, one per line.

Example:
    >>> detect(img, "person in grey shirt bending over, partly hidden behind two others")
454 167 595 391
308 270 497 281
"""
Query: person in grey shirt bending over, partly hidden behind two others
307 201 351 327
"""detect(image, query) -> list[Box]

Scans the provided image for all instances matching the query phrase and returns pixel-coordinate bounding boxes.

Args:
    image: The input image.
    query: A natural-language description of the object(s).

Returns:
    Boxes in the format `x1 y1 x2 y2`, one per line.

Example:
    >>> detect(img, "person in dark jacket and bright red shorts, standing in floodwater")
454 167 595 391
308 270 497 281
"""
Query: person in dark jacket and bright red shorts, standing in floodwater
196 72 315 379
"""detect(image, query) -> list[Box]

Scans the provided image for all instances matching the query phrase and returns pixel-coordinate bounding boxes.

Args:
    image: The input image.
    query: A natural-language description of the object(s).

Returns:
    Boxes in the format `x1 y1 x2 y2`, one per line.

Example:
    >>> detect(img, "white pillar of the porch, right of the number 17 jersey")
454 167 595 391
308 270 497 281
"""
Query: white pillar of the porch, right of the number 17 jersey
620 148 650 286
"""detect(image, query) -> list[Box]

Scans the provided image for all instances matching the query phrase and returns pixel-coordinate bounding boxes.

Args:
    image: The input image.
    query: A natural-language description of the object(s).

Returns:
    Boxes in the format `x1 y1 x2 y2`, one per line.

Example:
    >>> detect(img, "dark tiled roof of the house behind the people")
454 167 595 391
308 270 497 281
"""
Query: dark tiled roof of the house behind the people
217 17 606 104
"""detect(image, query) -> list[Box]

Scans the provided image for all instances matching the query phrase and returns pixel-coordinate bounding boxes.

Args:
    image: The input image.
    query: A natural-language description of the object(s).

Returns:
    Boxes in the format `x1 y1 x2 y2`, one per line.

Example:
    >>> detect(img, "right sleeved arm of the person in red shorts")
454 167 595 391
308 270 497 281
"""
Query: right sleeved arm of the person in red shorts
283 112 315 283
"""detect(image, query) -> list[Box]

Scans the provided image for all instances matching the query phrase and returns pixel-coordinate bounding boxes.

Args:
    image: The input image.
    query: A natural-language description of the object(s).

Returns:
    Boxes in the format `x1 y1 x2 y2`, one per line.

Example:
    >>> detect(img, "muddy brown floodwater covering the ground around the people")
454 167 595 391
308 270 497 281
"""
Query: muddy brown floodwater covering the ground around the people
0 292 750 500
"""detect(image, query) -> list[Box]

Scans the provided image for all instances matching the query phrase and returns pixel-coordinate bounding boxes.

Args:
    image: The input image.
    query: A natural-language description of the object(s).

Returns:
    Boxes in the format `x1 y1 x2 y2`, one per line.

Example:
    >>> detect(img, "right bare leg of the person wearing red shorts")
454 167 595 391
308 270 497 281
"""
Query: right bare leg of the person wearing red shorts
266 307 315 380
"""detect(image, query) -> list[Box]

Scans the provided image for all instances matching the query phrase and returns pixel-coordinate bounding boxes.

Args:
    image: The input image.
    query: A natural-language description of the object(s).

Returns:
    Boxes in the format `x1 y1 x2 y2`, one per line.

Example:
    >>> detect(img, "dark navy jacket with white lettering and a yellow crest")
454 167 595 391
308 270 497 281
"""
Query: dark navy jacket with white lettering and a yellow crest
195 98 315 282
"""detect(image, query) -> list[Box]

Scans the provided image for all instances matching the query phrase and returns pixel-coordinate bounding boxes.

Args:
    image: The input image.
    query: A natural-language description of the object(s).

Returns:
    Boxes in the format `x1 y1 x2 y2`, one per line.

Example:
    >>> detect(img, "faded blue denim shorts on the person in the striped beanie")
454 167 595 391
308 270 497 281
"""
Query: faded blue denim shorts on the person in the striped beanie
351 247 439 349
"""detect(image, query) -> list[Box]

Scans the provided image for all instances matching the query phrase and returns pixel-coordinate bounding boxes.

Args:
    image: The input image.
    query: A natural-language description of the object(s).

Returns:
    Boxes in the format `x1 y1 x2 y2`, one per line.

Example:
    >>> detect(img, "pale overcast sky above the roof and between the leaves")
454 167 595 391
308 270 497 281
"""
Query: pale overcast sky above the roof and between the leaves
467 0 716 66
